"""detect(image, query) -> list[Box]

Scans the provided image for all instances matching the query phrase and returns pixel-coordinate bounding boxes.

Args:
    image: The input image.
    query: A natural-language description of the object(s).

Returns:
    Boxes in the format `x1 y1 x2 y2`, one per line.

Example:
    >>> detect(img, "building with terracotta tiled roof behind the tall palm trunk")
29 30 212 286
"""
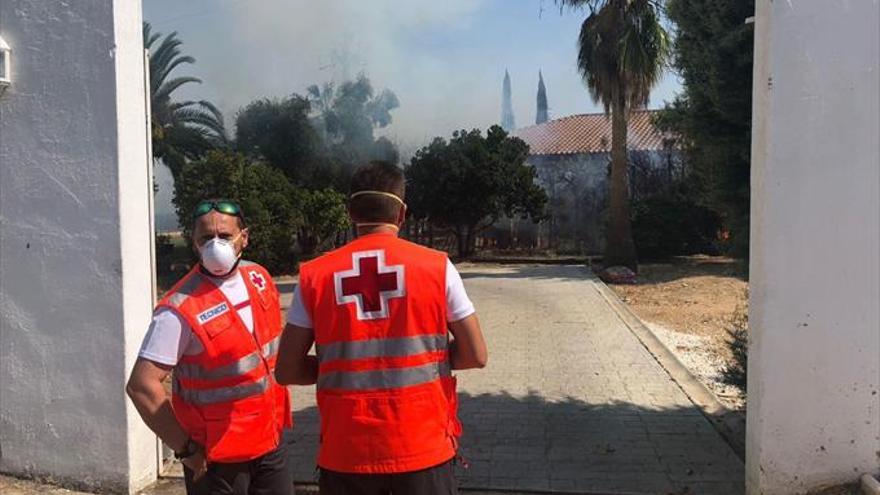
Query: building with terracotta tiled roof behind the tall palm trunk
512 110 682 254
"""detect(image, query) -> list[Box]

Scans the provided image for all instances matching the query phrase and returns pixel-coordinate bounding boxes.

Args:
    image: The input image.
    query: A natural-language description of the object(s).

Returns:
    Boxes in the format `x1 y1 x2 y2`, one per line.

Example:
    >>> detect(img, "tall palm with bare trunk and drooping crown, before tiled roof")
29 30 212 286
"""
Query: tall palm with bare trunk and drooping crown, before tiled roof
557 0 669 270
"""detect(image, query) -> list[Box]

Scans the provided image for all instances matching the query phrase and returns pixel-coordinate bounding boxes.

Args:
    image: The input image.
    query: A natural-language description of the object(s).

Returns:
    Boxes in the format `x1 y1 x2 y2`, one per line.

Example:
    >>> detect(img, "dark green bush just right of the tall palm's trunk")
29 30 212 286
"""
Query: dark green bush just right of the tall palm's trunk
632 192 721 261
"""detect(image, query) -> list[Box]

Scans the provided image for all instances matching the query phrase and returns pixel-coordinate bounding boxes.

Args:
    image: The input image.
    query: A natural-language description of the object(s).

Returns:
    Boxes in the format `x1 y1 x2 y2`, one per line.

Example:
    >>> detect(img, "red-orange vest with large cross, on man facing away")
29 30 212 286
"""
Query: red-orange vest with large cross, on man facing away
300 234 461 473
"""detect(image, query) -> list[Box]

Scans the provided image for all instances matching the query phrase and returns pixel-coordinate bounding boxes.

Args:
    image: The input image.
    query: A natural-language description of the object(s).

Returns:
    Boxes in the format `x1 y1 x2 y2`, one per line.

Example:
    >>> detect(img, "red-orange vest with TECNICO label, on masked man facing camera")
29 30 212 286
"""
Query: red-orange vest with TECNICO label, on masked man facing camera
158 261 293 462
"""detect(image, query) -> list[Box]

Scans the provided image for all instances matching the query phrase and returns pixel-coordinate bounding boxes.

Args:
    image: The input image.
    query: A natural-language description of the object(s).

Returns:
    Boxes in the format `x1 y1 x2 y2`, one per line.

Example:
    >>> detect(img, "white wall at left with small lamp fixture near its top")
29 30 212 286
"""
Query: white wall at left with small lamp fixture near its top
0 0 156 492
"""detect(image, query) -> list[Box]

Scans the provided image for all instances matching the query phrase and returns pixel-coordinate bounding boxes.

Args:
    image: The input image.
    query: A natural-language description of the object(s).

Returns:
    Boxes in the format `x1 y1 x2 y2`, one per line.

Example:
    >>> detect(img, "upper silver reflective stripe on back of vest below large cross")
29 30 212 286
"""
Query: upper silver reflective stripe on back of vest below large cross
318 334 448 363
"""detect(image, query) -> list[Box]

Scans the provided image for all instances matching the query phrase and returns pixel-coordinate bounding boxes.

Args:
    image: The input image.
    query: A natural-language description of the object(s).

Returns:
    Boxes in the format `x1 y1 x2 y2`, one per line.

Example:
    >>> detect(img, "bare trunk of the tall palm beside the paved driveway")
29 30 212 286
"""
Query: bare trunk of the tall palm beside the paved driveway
603 100 638 271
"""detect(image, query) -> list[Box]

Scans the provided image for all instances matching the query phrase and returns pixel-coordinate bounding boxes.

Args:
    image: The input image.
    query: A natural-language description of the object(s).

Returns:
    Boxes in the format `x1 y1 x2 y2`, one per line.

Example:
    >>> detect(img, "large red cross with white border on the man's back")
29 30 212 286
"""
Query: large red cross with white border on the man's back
333 250 406 320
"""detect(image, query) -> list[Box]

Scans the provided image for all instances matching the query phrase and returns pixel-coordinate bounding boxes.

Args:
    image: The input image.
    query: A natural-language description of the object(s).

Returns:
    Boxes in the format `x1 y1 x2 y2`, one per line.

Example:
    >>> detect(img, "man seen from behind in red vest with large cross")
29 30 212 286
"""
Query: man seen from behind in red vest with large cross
275 162 487 495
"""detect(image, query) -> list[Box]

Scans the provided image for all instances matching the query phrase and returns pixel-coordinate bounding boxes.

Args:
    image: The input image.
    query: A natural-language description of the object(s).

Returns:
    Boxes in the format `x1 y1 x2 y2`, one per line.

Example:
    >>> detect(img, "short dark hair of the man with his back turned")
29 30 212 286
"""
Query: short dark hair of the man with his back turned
348 161 406 222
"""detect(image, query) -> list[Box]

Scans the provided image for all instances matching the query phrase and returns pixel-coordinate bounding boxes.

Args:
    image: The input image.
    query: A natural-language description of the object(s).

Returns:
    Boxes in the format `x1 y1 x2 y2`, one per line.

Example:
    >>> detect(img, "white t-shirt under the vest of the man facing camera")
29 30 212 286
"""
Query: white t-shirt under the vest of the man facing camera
138 270 254 366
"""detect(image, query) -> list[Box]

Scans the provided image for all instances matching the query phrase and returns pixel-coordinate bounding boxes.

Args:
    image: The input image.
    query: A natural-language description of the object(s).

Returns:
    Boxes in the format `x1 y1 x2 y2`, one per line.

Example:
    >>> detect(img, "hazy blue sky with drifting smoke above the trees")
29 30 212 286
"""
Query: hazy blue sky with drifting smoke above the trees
143 0 680 227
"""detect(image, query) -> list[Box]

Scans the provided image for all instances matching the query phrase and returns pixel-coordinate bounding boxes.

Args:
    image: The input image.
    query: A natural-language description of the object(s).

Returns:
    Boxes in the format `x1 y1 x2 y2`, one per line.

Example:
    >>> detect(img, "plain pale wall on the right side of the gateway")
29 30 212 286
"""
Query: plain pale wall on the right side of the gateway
747 0 880 495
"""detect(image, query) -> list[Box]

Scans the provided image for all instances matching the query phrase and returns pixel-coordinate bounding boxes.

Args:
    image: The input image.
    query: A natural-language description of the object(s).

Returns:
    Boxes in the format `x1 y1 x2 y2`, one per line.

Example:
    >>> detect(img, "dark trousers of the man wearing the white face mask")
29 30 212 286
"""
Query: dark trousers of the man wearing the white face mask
183 444 294 495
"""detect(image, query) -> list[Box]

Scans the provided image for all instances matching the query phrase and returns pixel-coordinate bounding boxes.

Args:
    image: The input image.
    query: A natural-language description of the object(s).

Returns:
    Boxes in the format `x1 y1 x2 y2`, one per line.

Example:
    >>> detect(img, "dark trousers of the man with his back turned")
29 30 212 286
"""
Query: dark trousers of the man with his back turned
318 459 458 495
